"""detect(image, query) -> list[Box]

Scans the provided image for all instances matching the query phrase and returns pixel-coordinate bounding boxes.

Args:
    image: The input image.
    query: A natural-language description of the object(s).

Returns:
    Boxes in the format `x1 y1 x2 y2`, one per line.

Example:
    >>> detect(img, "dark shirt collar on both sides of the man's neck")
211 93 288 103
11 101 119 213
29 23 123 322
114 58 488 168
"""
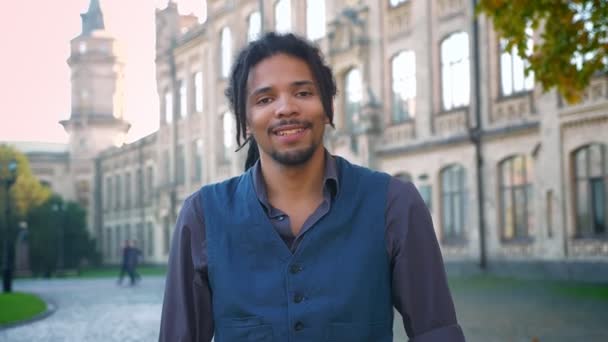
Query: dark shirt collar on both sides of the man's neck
252 150 340 216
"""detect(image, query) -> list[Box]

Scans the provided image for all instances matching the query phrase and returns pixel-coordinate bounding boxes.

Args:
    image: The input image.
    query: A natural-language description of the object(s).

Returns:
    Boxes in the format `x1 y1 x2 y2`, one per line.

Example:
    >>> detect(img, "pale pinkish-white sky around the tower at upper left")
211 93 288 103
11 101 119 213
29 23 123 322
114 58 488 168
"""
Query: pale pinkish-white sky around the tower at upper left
0 0 204 142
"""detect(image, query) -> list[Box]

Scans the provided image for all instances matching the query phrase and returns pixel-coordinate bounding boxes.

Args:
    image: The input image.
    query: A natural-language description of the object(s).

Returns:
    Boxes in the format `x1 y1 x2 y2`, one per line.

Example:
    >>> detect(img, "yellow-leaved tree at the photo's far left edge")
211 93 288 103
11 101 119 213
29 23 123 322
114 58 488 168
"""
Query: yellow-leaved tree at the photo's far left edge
0 145 51 292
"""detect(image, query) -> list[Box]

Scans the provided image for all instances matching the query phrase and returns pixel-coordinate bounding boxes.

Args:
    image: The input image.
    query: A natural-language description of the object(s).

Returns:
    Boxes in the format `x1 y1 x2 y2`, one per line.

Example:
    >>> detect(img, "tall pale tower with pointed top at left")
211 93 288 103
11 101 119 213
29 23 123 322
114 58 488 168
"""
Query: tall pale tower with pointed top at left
60 0 130 232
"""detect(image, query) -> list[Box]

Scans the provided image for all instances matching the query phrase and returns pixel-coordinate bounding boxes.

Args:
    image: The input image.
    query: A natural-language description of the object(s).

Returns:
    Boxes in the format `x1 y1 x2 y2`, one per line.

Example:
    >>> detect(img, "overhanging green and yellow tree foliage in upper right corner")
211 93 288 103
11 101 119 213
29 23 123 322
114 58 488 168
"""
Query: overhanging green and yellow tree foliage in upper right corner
477 0 608 103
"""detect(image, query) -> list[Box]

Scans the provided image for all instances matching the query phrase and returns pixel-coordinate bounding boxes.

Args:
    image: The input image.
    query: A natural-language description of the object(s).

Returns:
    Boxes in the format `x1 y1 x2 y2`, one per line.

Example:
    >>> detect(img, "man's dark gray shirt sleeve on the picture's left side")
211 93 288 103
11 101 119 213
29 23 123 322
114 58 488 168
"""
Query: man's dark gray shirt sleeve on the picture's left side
159 192 214 342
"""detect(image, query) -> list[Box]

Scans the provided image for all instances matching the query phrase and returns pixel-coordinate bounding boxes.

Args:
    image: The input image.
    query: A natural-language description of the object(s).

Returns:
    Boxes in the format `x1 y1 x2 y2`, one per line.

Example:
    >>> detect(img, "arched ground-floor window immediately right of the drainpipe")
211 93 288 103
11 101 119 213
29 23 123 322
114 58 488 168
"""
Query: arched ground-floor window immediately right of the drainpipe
499 156 534 240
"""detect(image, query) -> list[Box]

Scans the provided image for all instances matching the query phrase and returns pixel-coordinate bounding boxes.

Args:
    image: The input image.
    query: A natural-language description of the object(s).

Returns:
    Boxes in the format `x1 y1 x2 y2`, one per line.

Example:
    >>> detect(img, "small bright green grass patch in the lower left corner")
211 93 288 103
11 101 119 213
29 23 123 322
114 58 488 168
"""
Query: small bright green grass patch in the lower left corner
0 292 46 325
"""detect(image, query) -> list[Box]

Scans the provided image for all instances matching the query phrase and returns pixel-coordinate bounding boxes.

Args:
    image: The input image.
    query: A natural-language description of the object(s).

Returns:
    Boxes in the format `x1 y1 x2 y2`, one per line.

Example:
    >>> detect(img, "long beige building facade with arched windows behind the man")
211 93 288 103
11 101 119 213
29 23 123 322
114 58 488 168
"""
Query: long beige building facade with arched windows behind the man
16 0 608 280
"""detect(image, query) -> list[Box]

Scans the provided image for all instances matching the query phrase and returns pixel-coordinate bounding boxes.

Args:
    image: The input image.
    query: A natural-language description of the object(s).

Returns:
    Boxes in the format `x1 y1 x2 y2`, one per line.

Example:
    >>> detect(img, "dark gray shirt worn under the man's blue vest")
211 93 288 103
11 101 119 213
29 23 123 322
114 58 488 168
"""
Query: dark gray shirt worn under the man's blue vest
159 153 464 342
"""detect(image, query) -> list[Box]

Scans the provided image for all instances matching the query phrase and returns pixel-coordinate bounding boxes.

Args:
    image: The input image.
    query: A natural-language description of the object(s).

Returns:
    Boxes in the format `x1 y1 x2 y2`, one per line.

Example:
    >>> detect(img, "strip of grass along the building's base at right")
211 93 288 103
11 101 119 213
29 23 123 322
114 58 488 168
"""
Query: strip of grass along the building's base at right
448 275 608 301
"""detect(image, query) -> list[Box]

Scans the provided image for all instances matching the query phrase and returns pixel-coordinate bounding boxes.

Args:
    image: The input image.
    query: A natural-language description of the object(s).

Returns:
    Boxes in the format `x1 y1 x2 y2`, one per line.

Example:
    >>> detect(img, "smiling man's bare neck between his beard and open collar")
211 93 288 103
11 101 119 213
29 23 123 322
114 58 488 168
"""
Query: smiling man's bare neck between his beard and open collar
260 147 326 204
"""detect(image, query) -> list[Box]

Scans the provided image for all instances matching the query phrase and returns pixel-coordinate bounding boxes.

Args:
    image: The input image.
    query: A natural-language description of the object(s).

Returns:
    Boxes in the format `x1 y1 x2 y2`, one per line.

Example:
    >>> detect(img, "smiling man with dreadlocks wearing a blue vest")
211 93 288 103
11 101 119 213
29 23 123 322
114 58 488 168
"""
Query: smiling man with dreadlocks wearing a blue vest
160 33 464 342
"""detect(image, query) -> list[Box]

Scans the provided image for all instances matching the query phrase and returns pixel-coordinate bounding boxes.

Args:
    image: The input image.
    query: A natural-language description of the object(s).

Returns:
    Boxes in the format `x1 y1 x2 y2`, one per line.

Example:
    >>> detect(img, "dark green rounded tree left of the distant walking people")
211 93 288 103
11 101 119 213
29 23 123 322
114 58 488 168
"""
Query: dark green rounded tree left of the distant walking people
28 194 100 277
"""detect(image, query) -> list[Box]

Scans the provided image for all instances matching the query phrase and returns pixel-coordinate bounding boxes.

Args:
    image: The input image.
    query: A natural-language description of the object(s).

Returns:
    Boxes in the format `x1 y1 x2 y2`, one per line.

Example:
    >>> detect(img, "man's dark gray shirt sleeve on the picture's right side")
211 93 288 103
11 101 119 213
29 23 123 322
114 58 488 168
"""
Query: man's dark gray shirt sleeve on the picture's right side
386 178 465 342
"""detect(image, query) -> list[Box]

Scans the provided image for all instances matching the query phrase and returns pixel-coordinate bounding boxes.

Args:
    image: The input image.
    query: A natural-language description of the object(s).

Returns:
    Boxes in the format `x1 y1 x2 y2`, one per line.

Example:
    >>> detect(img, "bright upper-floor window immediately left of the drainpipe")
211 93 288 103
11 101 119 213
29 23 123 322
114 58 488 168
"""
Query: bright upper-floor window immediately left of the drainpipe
441 32 470 110
